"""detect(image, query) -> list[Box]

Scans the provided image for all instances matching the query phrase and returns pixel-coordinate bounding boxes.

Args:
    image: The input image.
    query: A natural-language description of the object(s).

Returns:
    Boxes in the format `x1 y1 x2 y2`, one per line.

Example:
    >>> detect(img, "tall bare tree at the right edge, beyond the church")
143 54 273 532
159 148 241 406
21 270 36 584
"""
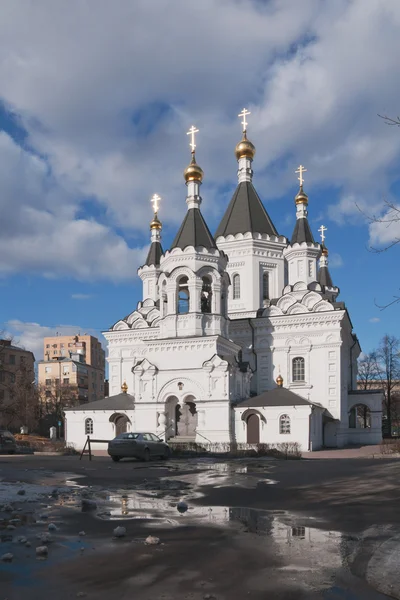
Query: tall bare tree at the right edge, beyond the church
375 335 400 435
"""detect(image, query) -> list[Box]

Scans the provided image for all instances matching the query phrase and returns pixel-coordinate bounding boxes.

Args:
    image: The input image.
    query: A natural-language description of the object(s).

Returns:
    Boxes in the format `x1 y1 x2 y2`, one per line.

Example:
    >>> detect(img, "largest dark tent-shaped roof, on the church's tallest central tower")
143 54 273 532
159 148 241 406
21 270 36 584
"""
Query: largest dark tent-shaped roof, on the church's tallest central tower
215 181 279 238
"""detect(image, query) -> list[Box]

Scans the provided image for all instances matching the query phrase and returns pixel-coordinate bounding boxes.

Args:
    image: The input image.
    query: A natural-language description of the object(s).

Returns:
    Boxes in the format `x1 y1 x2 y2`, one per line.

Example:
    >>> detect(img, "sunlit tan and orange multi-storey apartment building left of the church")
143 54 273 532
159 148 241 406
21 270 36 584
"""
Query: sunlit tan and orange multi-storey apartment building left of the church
38 335 105 405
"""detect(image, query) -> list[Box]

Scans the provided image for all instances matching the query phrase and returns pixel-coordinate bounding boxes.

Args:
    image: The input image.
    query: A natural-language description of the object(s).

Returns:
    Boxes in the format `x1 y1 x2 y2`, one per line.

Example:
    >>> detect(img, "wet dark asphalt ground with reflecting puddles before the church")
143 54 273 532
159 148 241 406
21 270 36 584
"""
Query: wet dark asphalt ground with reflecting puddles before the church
0 451 400 600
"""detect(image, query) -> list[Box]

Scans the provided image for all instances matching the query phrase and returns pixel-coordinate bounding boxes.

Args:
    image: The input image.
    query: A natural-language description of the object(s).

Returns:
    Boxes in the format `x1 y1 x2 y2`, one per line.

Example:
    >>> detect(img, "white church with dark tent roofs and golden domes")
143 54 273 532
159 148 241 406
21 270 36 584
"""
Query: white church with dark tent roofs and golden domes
65 110 382 451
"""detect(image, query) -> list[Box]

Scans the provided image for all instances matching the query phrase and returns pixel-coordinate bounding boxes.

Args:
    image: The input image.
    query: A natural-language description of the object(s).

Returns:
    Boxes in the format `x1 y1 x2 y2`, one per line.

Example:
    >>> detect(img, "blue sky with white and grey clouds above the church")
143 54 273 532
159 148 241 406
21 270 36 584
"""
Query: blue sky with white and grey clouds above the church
0 0 400 358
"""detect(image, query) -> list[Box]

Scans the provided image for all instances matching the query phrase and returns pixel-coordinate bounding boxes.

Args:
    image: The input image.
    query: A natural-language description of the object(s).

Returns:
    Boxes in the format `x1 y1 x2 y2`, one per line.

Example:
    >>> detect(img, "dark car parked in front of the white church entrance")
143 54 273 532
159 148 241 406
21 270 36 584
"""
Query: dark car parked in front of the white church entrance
108 432 171 462
